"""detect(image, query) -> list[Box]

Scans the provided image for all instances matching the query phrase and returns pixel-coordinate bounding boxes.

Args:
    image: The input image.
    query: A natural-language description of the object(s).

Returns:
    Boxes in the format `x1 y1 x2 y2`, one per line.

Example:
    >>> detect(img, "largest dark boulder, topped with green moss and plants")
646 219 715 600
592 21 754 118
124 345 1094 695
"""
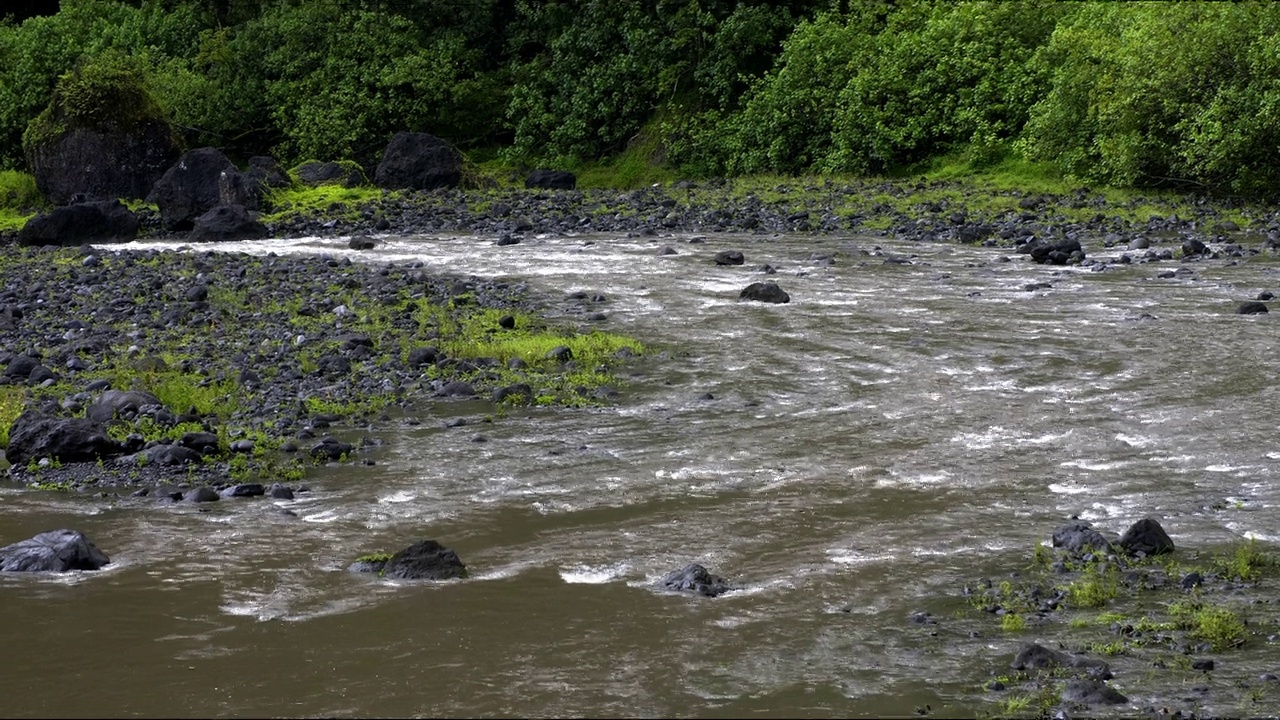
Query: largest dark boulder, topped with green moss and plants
22 55 179 205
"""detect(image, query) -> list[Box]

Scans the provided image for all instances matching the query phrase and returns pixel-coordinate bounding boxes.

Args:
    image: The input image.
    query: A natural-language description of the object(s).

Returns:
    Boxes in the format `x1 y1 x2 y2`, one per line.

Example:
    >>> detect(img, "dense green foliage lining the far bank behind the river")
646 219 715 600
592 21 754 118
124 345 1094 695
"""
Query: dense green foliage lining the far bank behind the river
0 0 1280 195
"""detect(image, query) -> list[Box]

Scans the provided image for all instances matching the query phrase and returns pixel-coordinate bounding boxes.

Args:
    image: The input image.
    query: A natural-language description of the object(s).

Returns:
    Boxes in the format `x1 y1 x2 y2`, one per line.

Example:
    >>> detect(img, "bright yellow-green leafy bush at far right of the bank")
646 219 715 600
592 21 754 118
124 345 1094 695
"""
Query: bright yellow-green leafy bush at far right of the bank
1019 3 1280 192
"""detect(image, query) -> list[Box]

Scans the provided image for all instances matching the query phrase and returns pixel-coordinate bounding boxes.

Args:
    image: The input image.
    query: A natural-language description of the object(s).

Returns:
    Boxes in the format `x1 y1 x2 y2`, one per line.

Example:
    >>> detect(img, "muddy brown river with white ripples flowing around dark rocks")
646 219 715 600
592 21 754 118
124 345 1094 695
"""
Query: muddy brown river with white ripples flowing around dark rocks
0 234 1280 717
